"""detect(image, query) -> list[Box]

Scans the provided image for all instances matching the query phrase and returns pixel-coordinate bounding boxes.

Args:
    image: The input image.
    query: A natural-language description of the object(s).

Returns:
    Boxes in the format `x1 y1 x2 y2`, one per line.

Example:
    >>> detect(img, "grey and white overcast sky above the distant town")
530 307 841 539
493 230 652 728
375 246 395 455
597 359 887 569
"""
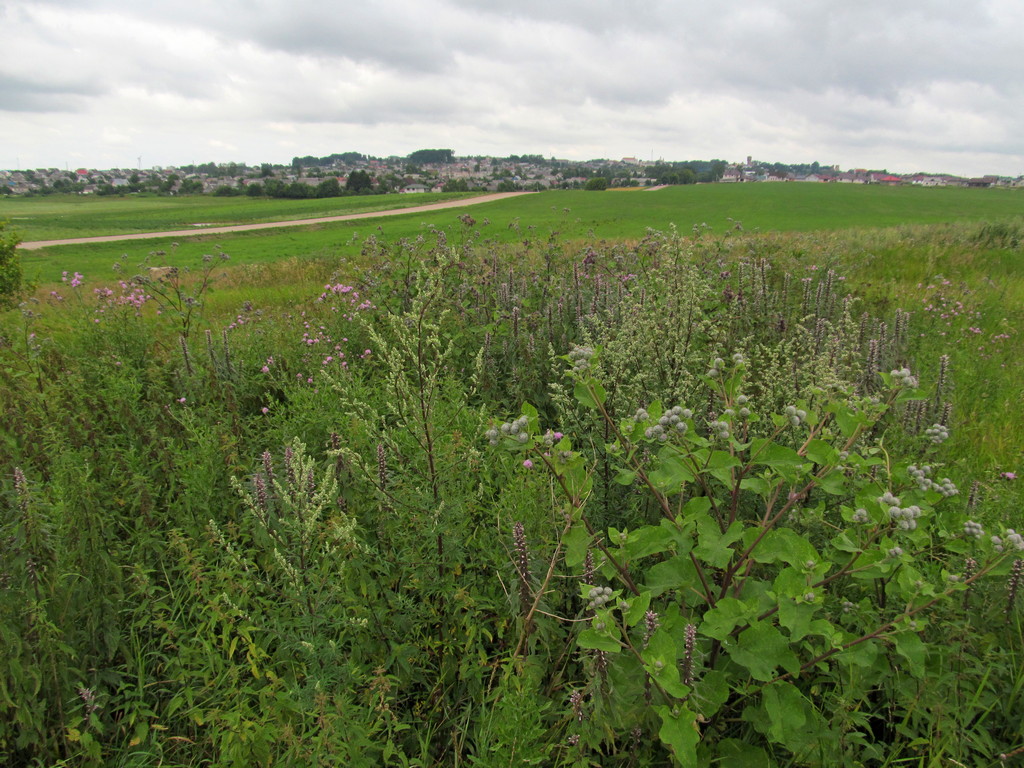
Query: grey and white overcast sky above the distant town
0 0 1024 175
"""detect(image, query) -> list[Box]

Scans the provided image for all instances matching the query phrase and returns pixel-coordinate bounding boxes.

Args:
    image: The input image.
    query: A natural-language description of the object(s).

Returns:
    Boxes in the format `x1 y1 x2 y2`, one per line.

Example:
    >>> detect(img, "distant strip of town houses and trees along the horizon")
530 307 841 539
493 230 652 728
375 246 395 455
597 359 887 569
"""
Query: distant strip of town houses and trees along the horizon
0 150 1024 199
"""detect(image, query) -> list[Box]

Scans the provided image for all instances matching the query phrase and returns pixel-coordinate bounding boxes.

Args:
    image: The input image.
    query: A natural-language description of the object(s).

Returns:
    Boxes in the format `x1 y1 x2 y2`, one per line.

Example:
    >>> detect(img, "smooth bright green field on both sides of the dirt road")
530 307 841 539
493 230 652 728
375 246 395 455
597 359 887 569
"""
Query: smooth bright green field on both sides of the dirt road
12 183 1024 284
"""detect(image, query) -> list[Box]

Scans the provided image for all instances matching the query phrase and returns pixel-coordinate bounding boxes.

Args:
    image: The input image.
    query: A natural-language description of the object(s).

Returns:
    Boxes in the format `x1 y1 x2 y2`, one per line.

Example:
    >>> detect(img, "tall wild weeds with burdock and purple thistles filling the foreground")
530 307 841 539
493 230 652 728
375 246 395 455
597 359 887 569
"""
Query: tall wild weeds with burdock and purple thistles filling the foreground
0 193 1024 766
